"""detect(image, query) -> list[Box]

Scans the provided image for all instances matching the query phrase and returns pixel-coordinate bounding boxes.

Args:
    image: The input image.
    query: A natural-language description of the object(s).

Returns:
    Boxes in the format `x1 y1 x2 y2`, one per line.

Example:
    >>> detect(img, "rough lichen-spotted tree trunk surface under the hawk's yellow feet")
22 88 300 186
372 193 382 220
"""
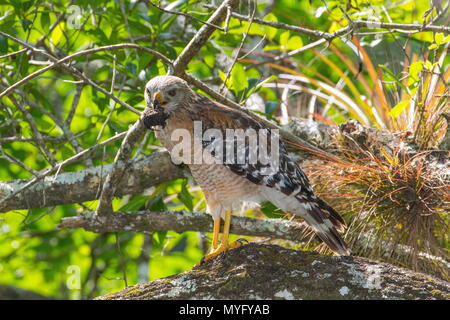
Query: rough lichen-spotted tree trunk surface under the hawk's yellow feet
97 243 450 300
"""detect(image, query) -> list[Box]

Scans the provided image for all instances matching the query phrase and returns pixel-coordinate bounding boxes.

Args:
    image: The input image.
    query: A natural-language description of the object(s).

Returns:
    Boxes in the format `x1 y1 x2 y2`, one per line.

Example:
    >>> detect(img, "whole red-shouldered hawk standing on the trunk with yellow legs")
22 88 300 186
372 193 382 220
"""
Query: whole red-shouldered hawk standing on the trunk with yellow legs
142 76 350 260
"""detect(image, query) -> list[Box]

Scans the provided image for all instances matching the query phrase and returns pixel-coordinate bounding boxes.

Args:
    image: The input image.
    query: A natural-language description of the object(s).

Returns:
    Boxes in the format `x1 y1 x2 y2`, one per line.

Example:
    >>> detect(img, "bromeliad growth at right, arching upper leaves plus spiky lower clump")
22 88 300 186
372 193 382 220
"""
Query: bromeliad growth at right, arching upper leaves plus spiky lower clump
248 36 450 279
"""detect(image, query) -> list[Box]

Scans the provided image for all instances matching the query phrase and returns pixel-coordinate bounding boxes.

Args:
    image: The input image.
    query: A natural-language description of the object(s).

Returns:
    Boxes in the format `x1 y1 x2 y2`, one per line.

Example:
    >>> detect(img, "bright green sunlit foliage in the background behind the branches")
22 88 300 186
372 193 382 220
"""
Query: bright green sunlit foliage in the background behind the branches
0 0 448 299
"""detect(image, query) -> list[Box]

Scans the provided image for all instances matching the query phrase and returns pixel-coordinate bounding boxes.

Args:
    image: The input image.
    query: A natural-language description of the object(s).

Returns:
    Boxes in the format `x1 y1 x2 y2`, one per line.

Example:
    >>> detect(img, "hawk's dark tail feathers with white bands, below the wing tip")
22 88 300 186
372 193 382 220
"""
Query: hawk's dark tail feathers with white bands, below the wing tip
299 199 350 255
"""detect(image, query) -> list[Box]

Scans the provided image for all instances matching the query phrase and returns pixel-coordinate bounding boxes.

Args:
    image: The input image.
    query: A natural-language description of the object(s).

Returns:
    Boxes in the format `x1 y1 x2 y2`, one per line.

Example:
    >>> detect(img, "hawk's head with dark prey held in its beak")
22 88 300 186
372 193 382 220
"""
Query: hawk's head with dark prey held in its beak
143 76 194 129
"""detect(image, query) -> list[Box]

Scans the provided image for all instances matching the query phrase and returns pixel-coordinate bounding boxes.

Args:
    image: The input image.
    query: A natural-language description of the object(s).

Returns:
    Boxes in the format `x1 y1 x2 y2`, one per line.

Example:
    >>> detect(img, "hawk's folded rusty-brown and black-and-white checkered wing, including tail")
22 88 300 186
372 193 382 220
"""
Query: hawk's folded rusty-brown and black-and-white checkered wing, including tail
191 95 348 254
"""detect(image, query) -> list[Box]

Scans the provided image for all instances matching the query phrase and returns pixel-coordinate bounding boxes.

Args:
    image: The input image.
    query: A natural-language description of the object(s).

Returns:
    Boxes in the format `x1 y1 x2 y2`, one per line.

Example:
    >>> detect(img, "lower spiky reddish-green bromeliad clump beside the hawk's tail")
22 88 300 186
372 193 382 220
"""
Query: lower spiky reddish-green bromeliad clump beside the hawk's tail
305 121 450 279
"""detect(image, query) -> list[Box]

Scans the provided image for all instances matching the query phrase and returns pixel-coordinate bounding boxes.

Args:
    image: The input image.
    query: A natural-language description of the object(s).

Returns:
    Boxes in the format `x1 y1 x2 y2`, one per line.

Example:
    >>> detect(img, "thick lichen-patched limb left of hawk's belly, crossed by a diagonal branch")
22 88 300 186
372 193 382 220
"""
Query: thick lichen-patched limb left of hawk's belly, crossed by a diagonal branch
0 152 188 212
